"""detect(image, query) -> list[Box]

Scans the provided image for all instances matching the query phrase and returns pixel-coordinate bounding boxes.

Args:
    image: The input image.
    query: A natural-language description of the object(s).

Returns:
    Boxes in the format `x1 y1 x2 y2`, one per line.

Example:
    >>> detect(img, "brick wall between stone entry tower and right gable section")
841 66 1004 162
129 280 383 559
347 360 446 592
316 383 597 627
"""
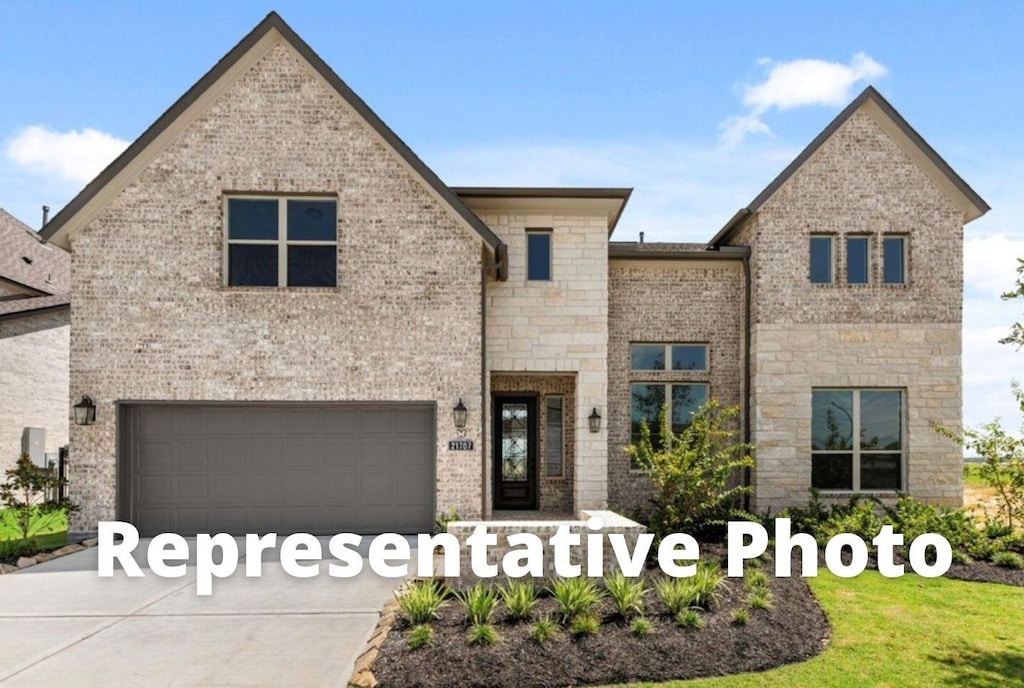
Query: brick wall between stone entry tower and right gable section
607 260 743 513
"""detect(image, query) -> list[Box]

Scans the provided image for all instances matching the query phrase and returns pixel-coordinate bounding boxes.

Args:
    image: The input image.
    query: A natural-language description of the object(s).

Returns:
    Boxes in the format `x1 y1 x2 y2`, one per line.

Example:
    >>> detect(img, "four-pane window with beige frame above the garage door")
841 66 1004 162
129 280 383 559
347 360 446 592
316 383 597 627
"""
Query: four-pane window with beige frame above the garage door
224 197 338 287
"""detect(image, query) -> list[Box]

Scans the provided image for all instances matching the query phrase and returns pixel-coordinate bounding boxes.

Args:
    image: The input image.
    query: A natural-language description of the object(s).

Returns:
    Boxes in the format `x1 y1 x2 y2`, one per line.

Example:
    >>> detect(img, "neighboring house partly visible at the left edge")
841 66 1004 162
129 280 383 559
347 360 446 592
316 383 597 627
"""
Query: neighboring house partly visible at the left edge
0 209 71 480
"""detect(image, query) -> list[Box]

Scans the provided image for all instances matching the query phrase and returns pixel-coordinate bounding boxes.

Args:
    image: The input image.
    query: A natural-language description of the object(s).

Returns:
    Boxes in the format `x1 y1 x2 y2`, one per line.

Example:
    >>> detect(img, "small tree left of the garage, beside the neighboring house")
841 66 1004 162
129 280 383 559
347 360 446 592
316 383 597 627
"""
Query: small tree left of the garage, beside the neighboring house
0 454 78 542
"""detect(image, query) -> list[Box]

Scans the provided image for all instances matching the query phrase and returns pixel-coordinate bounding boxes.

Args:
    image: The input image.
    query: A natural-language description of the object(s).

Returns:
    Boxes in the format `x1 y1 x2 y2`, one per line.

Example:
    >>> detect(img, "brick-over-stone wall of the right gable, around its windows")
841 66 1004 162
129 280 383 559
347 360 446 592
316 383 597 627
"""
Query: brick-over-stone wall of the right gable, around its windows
730 107 964 509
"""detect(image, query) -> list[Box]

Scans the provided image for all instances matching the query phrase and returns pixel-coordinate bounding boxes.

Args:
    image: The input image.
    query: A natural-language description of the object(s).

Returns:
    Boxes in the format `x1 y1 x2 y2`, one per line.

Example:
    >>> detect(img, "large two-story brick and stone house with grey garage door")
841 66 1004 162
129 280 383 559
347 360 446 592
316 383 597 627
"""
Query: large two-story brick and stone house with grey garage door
37 14 987 533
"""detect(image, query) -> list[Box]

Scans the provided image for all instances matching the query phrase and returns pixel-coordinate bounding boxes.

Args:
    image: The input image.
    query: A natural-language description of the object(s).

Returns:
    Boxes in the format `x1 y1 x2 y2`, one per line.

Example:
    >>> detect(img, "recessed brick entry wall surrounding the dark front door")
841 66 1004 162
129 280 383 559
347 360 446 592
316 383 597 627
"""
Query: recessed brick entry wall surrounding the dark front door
490 373 577 514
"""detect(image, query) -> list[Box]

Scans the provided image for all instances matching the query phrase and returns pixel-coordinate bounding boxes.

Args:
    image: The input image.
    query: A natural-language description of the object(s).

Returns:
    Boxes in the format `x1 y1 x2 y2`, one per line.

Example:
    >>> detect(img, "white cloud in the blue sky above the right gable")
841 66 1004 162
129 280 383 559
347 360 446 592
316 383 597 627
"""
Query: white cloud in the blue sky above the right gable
720 52 889 146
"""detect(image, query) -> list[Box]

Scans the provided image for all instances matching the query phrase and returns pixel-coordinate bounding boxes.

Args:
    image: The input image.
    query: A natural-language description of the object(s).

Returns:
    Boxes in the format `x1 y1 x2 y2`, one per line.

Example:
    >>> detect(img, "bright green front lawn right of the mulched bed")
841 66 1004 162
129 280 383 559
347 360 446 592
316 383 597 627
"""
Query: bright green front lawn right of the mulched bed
614 571 1024 688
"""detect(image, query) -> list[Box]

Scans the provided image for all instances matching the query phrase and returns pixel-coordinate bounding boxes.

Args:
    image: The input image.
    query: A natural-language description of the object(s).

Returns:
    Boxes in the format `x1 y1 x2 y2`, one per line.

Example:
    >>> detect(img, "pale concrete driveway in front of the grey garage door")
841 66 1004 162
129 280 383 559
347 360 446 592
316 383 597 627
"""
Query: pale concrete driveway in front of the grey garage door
0 539 407 688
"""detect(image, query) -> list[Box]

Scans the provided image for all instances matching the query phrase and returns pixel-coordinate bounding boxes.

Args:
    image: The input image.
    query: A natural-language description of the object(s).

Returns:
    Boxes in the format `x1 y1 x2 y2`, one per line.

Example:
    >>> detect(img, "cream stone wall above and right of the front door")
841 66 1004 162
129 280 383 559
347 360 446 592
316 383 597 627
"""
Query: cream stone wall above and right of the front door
480 212 608 509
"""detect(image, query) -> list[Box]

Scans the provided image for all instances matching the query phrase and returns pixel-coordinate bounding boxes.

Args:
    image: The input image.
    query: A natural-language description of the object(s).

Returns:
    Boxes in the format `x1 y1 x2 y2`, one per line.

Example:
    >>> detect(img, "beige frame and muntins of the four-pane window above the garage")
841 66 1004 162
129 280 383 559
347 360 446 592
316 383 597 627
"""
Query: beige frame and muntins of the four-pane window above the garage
221 191 339 290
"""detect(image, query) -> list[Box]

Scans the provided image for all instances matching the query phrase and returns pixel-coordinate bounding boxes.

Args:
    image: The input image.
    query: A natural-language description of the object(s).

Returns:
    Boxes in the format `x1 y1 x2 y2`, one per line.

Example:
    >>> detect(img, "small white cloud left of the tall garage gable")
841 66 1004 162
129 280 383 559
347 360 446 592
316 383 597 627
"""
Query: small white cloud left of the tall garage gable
6 125 129 184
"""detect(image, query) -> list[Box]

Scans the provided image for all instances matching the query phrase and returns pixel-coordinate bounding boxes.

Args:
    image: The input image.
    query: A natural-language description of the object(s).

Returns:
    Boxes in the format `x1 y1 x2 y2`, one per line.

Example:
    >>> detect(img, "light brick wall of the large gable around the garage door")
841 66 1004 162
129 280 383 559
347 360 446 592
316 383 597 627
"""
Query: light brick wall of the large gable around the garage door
71 40 482 529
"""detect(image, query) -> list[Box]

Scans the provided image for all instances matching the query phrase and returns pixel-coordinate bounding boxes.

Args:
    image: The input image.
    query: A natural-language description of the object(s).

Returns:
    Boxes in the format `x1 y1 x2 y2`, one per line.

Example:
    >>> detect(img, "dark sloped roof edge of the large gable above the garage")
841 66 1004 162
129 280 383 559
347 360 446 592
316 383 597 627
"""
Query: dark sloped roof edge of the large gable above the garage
40 12 502 249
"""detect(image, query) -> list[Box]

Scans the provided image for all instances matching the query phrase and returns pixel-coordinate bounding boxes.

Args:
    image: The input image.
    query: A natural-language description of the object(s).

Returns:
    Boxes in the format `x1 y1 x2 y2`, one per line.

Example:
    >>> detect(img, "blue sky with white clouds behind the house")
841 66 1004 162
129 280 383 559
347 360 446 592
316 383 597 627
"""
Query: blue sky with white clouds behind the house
0 0 1024 424
